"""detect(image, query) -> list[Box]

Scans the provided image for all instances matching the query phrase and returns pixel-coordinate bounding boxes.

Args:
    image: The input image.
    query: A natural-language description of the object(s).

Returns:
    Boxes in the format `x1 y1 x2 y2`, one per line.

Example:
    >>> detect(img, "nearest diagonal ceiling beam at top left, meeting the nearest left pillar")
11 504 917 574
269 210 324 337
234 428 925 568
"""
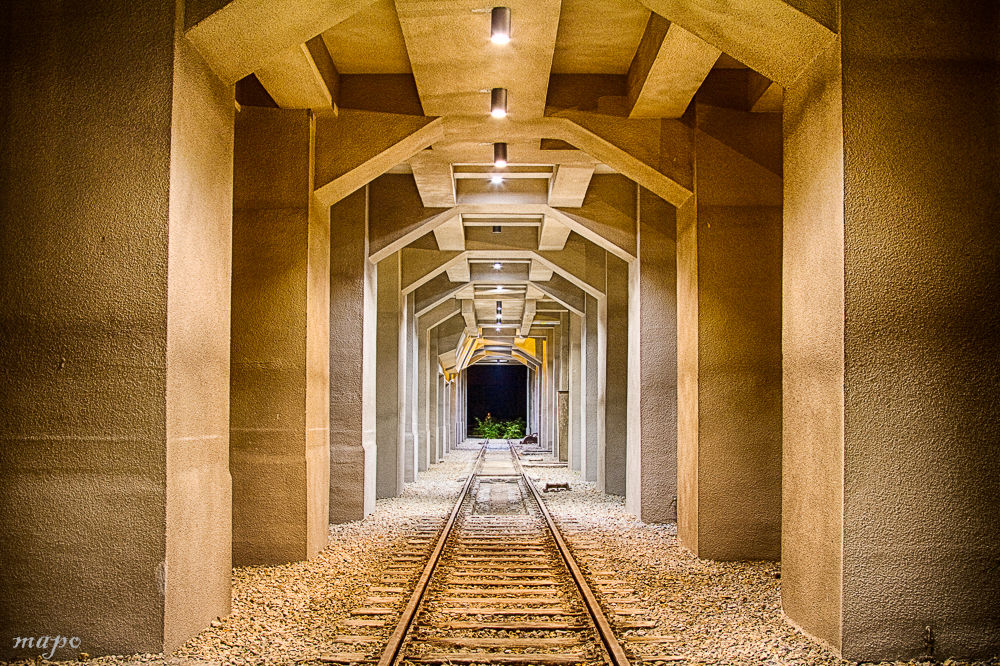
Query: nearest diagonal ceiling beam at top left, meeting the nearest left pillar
185 0 375 85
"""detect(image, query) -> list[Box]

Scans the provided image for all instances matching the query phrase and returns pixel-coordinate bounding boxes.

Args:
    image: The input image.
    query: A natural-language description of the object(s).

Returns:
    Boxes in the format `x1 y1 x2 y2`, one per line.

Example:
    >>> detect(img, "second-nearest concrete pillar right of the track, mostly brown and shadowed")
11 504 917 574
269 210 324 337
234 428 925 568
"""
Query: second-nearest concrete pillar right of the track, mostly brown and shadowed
677 96 782 560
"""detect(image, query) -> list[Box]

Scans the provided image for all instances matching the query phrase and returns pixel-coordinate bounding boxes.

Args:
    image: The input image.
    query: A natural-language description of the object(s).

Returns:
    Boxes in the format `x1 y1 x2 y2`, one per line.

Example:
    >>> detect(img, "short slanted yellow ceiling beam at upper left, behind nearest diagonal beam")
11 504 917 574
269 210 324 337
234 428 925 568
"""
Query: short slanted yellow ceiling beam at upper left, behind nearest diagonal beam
255 37 340 112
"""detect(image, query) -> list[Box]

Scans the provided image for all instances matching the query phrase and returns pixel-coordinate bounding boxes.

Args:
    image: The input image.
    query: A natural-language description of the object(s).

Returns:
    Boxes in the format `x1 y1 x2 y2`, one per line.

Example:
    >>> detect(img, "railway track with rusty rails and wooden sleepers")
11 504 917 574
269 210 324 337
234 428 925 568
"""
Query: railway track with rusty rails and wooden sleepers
321 446 676 666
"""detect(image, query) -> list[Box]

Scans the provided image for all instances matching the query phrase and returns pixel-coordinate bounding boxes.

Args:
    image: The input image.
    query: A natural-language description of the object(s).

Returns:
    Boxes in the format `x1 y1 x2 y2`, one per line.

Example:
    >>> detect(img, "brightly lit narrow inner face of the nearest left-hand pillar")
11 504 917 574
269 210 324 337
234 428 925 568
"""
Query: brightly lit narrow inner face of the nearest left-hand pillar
163 33 234 652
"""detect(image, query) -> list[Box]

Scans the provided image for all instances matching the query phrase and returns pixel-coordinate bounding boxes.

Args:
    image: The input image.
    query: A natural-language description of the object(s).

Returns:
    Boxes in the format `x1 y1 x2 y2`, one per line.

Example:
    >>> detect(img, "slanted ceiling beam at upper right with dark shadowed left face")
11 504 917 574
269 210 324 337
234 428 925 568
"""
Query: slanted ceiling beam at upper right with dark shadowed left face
627 13 722 118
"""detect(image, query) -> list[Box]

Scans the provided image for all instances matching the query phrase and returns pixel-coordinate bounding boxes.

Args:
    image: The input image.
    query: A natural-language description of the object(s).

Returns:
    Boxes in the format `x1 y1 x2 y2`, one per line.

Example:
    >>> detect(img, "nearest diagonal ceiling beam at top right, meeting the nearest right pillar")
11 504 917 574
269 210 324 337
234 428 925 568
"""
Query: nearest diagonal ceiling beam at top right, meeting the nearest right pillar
640 0 836 87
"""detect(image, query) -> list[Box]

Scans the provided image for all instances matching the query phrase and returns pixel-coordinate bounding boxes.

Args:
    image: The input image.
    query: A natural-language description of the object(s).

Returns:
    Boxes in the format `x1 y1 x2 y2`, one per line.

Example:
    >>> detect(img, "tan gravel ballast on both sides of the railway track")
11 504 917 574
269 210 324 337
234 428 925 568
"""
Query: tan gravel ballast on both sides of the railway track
0 448 1000 666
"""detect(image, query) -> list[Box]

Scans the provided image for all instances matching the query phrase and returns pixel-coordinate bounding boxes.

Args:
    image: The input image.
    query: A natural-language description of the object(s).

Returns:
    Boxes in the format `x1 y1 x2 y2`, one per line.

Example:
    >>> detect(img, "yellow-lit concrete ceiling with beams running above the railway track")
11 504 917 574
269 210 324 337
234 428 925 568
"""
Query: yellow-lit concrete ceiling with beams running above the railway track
240 0 821 358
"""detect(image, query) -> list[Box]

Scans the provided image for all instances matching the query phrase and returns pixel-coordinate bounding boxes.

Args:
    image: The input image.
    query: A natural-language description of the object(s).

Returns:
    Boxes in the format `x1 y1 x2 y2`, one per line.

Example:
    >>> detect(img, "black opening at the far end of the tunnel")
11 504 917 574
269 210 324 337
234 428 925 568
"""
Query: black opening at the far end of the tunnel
465 363 528 436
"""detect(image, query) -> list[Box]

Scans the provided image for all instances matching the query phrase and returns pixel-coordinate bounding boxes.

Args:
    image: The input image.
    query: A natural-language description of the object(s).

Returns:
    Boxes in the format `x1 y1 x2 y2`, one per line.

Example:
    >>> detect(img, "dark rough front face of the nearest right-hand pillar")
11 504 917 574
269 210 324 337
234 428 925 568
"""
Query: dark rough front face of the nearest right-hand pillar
841 0 1000 659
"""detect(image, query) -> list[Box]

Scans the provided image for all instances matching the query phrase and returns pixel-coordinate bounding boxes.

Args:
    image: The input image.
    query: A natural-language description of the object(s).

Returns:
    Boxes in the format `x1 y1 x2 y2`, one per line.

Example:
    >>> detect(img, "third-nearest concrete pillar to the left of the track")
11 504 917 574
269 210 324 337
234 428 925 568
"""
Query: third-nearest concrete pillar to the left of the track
330 188 377 523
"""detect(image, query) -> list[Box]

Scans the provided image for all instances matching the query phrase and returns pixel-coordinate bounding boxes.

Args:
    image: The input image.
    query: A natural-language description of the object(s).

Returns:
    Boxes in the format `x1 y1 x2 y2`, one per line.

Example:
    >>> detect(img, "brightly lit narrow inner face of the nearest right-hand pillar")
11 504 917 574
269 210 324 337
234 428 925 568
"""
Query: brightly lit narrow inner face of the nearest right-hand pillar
781 35 844 649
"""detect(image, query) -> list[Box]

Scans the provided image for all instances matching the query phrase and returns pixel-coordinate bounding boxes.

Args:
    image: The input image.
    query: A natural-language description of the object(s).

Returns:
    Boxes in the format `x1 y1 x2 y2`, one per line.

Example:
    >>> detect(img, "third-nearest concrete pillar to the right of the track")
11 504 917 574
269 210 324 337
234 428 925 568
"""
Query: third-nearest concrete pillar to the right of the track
625 188 677 523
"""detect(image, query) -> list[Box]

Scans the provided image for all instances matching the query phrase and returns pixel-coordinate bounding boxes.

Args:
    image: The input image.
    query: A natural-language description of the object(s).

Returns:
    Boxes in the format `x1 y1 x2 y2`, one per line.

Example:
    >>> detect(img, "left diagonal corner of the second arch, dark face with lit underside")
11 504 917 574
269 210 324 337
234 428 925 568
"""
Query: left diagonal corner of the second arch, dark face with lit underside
315 110 443 206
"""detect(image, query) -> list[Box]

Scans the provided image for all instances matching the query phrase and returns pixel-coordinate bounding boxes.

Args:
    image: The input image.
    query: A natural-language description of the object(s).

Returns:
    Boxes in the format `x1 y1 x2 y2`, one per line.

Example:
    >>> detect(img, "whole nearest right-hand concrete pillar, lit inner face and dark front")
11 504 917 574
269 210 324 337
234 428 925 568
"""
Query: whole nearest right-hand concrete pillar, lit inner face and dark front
782 5 1000 661
